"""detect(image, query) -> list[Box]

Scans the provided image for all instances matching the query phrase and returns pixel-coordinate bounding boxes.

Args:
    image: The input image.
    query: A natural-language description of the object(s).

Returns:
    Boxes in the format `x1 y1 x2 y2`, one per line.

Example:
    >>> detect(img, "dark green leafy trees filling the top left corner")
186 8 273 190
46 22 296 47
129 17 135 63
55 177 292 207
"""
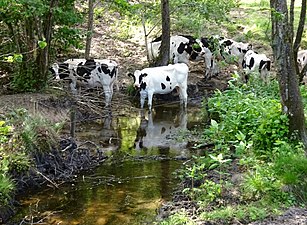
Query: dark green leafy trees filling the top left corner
0 0 82 92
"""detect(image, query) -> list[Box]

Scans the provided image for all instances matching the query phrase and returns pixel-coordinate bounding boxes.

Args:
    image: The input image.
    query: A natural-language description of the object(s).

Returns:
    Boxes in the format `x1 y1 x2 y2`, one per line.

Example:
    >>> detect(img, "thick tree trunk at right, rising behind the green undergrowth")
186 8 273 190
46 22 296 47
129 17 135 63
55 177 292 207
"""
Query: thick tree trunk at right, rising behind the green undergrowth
270 0 307 151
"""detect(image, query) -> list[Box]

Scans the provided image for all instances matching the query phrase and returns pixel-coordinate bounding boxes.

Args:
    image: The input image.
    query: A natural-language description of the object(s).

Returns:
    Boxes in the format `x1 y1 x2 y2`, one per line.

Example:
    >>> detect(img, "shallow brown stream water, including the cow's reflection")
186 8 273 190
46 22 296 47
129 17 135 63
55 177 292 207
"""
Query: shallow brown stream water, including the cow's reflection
10 106 205 225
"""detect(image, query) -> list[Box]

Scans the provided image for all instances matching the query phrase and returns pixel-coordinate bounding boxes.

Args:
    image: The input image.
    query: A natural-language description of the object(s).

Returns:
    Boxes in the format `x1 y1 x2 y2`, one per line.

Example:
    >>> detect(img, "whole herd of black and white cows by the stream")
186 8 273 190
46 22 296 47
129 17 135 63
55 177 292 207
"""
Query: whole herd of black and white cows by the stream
50 35 307 110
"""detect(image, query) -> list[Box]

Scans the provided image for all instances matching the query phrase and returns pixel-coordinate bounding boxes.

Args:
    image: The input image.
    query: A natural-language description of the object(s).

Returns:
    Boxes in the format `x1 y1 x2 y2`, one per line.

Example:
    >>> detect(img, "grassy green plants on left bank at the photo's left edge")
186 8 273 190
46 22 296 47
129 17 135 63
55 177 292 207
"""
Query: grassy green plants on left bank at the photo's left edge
0 109 62 205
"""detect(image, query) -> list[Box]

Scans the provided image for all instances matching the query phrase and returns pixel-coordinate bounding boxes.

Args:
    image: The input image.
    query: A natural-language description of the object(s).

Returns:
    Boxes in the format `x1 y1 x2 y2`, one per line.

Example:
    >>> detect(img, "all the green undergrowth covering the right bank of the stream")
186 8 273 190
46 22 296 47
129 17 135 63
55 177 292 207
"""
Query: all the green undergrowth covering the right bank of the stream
162 76 307 224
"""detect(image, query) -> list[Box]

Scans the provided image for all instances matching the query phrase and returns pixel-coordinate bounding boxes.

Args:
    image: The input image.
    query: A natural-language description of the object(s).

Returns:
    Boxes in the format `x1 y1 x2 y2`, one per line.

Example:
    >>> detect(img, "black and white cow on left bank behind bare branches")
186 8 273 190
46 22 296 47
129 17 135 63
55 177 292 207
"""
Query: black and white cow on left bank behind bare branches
49 59 118 105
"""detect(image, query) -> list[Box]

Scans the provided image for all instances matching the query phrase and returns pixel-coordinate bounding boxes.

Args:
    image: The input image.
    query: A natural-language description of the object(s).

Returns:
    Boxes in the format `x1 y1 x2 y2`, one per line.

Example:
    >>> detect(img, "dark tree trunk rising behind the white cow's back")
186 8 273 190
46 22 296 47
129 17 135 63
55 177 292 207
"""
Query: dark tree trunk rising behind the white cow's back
157 0 170 66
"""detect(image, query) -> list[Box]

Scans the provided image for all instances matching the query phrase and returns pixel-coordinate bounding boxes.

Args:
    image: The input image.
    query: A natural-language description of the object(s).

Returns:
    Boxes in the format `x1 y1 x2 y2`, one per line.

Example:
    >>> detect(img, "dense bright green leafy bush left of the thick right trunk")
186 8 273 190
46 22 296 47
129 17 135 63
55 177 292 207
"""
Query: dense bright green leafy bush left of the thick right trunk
204 74 288 157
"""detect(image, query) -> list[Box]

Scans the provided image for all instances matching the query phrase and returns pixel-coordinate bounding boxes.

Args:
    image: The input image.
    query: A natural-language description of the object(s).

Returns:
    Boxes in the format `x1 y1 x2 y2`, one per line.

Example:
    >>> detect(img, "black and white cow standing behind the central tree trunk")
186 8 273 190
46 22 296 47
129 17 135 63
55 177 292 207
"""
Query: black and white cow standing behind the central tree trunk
148 35 205 64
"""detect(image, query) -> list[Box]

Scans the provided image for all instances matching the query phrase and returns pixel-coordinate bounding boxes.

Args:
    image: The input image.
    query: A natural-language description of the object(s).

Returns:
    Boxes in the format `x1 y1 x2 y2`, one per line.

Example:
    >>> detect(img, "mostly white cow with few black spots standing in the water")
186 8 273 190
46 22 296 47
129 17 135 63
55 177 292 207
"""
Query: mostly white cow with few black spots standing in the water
128 63 189 111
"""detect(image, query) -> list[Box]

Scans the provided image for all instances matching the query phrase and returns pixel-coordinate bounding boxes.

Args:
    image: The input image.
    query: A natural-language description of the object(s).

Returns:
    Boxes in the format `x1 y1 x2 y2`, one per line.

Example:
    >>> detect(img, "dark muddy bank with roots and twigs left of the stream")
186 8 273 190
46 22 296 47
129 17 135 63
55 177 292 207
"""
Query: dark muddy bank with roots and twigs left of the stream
0 135 107 223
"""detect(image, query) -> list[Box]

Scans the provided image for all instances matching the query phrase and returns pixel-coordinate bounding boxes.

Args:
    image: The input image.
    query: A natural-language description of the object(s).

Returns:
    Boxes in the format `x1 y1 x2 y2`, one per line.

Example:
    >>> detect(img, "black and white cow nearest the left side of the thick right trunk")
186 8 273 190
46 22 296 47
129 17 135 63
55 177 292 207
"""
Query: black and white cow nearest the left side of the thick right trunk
242 50 271 83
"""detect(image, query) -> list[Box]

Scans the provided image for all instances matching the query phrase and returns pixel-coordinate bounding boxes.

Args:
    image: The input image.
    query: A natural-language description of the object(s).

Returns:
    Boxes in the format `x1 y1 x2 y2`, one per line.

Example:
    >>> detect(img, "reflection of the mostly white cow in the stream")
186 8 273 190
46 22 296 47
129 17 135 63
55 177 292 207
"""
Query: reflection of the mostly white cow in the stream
134 108 187 150
